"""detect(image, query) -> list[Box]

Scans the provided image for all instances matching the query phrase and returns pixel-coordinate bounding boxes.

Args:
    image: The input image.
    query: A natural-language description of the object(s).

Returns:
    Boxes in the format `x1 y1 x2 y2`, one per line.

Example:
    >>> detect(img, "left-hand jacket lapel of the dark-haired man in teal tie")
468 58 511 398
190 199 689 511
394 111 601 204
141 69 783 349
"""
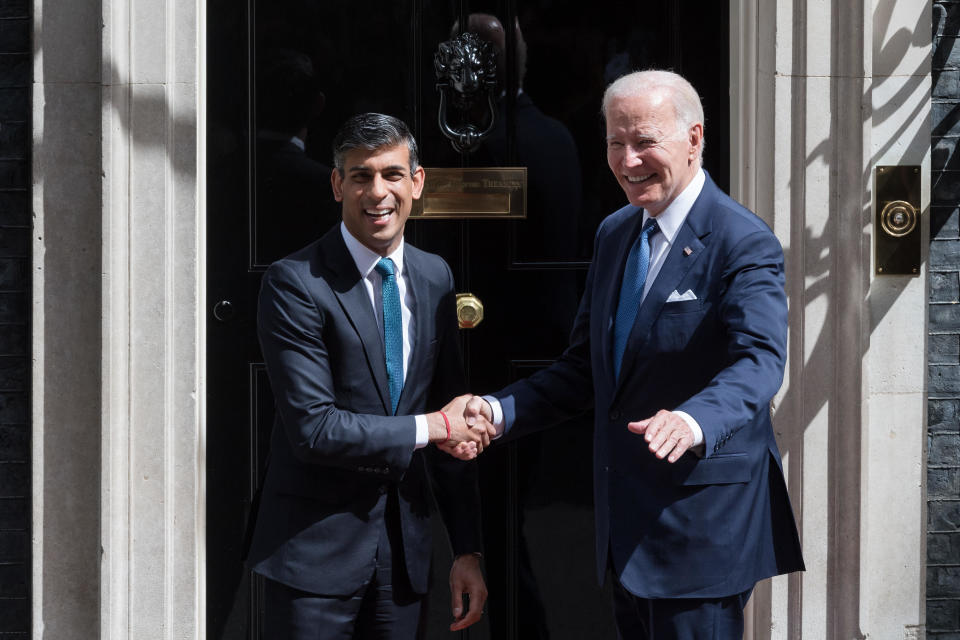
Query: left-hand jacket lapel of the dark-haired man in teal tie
319 230 390 414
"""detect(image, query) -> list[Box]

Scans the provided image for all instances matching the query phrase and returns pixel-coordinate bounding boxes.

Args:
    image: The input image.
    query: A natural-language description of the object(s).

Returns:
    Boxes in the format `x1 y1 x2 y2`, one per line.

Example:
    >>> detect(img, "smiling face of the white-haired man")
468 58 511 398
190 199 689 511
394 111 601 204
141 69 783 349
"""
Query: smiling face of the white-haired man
606 89 703 216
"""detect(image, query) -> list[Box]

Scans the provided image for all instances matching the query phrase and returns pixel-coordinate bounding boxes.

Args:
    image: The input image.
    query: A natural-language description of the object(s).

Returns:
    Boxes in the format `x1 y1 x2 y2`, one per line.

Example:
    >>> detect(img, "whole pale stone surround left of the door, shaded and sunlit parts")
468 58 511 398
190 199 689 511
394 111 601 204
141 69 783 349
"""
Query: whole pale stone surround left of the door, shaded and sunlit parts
32 0 206 640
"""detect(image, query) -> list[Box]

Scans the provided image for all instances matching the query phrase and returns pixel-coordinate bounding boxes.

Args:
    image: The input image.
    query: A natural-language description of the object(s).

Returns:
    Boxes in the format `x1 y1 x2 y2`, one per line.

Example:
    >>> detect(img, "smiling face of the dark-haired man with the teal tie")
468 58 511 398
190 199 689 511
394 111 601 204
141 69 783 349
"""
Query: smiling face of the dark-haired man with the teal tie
330 144 424 256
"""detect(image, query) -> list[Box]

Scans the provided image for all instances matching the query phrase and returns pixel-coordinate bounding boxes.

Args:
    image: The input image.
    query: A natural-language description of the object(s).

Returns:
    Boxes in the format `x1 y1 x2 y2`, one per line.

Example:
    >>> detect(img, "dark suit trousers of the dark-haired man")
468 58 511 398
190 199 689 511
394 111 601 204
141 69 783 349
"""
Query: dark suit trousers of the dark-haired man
262 492 426 640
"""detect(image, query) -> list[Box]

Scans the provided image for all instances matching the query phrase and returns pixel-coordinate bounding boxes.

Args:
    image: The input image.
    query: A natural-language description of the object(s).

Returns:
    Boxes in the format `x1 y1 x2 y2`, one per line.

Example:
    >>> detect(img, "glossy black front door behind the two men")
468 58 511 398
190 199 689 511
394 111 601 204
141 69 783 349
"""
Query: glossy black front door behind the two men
206 0 729 640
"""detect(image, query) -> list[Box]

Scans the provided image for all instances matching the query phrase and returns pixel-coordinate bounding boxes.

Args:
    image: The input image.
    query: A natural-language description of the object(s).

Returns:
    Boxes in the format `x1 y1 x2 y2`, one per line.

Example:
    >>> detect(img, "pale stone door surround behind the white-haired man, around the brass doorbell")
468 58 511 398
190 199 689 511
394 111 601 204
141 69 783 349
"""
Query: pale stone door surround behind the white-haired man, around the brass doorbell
731 0 932 639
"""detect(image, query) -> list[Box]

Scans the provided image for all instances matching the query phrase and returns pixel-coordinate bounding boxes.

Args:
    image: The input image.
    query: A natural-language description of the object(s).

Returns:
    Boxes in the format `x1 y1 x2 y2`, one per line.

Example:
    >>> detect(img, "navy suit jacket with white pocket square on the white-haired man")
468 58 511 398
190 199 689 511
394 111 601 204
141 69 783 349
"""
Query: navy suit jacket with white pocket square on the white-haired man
494 176 803 598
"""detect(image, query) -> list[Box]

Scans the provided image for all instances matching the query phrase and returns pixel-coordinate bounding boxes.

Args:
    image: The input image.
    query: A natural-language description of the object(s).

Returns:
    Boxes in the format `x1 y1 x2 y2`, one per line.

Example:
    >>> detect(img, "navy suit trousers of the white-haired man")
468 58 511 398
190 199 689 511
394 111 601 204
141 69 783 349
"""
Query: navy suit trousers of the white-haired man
610 571 753 640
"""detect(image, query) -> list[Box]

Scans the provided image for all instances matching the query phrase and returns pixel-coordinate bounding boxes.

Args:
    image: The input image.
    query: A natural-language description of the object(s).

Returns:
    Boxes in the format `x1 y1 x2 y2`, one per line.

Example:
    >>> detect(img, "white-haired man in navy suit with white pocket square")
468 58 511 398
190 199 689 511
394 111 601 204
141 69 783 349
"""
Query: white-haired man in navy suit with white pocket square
467 71 803 639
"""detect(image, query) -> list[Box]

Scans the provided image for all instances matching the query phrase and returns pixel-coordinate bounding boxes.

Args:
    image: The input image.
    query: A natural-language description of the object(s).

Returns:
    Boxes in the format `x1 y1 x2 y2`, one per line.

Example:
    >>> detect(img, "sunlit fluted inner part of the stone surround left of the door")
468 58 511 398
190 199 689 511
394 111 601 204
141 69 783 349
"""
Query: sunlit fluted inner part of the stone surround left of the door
100 0 206 640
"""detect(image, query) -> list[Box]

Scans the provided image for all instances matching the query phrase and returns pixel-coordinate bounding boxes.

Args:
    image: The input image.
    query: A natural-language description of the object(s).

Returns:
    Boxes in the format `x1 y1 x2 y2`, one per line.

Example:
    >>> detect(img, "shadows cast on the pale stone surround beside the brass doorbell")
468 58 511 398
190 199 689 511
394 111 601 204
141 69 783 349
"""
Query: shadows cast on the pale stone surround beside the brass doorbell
754 0 932 639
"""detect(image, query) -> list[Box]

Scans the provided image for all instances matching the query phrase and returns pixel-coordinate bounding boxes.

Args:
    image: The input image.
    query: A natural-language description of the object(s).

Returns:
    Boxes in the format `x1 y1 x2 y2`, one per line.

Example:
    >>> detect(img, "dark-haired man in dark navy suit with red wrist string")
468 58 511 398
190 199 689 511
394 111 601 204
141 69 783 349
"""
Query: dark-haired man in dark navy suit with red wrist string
248 114 492 640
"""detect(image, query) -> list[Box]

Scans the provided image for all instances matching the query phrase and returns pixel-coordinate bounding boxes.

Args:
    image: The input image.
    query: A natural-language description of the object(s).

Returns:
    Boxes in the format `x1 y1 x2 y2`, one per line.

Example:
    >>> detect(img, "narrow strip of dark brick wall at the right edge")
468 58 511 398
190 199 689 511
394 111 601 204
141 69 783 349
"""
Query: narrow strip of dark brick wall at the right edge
927 1 960 640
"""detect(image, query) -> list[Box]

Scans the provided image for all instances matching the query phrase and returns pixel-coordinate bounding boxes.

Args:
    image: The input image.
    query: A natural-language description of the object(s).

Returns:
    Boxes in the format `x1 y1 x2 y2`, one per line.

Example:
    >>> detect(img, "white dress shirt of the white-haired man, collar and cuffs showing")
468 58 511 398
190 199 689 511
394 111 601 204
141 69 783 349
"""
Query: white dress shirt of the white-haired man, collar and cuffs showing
483 169 706 456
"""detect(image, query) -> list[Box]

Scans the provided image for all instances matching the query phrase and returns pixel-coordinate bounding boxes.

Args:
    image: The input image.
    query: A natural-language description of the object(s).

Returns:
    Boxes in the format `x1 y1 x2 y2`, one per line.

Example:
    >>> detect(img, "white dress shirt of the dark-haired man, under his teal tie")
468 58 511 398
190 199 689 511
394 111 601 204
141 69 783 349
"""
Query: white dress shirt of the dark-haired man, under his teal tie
340 222 430 449
